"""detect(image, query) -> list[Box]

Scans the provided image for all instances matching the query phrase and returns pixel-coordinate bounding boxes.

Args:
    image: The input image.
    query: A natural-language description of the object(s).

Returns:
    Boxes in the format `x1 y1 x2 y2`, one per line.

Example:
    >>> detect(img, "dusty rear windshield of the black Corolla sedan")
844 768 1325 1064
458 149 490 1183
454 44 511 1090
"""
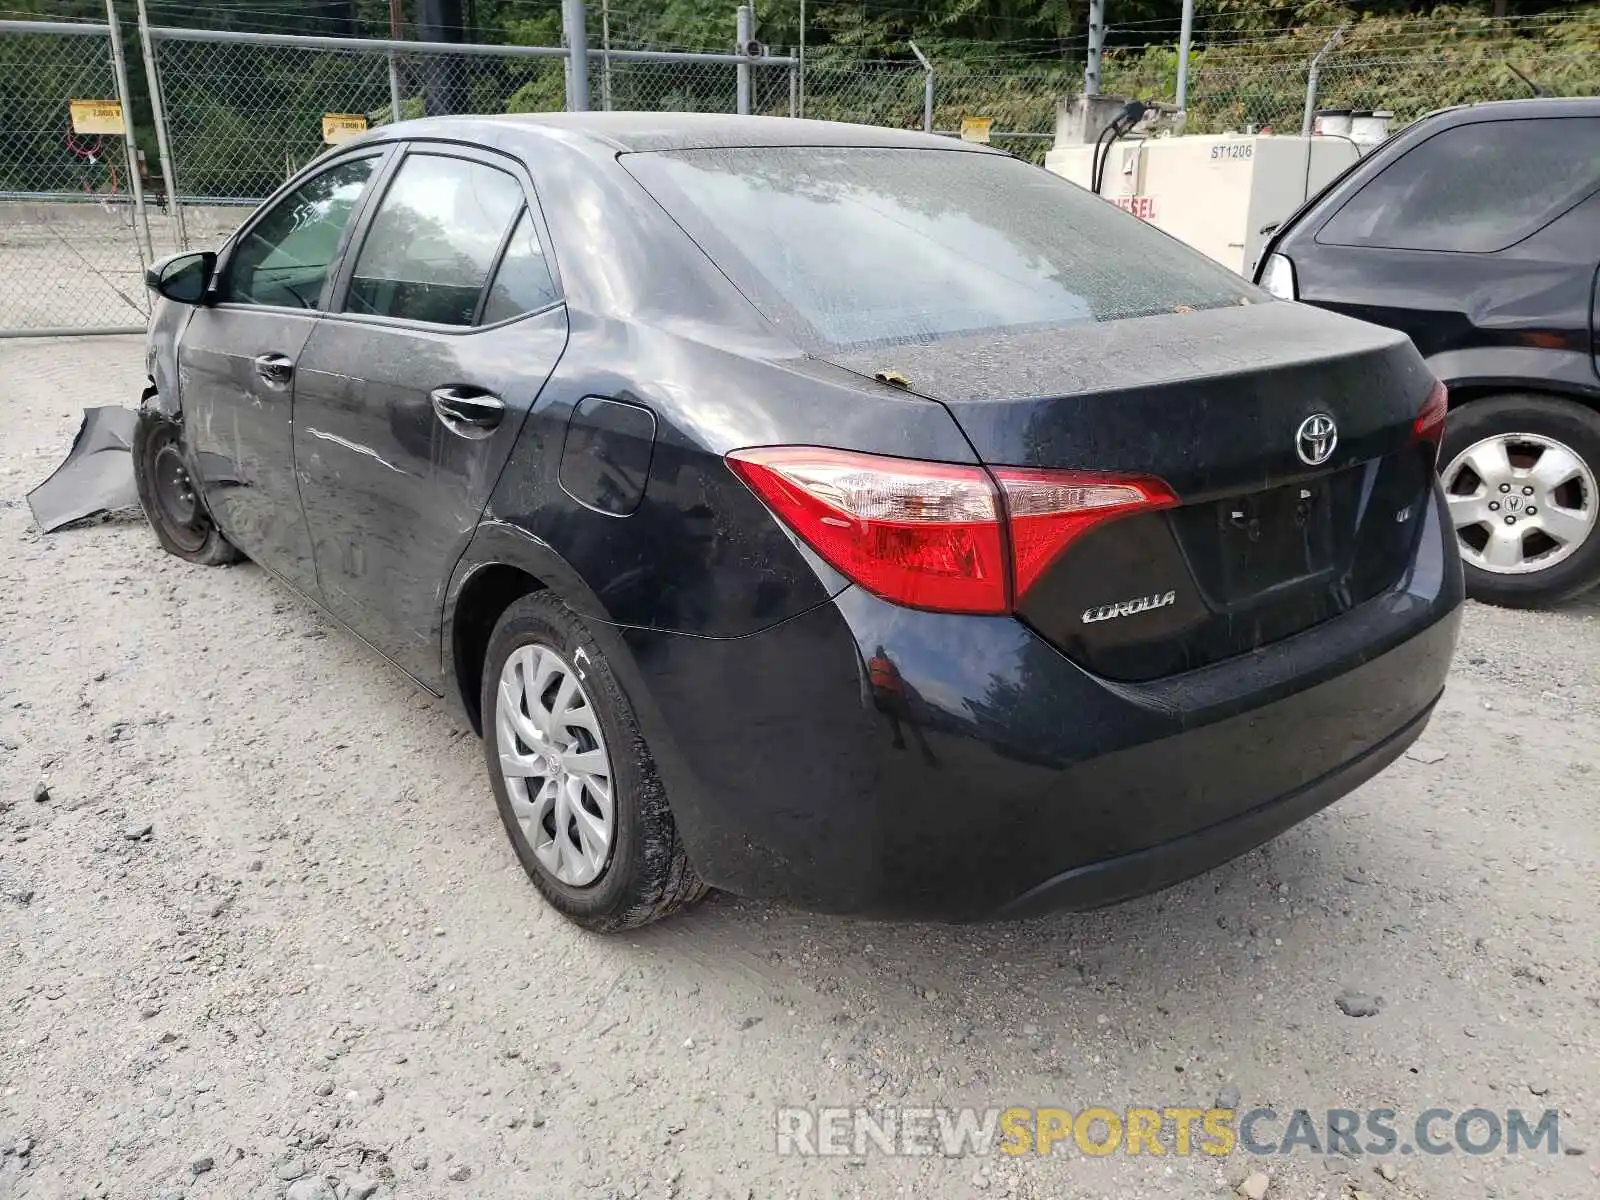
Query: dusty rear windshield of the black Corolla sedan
622 146 1266 349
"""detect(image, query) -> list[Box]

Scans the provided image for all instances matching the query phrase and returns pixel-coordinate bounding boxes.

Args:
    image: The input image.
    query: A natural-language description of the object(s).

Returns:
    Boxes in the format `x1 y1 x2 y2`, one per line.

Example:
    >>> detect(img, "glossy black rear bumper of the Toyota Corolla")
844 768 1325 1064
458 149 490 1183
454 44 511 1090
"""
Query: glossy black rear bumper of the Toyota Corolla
618 489 1461 920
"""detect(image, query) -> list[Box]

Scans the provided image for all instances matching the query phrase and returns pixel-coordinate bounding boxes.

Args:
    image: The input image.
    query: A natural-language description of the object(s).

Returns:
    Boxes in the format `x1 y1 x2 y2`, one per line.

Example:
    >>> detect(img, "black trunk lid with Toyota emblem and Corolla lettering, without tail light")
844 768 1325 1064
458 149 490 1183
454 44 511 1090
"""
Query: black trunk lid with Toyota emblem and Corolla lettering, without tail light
829 302 1434 680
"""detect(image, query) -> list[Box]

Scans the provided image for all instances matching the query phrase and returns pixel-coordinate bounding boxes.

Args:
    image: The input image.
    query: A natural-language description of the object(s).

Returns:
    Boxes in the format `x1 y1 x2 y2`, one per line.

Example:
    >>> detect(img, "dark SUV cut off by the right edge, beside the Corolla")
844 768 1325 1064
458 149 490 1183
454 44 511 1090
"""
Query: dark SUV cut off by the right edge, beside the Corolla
1256 99 1600 606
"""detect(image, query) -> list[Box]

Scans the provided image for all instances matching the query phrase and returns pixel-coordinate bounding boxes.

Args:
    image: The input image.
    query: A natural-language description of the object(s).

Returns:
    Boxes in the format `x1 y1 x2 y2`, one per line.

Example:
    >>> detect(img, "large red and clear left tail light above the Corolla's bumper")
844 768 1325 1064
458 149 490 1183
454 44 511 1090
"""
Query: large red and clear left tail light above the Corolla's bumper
728 446 1178 613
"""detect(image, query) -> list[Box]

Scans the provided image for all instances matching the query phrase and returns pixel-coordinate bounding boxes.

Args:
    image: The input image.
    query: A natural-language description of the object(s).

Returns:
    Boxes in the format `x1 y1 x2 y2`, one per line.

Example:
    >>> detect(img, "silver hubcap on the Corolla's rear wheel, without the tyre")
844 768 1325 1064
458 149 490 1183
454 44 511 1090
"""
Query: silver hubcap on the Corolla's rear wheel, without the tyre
494 645 616 888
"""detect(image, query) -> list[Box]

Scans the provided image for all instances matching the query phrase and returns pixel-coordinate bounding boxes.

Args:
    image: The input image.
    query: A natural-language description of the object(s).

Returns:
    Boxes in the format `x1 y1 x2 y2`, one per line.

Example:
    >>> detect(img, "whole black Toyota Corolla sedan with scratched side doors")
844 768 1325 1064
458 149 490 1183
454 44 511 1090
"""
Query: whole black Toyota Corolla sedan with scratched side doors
134 114 1461 930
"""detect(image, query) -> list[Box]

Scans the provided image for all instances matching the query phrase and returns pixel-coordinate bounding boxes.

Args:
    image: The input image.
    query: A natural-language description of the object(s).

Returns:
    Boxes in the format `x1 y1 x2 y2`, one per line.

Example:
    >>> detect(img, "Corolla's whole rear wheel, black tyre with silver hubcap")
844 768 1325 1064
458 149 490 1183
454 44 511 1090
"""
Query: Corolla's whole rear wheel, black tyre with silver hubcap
480 592 707 933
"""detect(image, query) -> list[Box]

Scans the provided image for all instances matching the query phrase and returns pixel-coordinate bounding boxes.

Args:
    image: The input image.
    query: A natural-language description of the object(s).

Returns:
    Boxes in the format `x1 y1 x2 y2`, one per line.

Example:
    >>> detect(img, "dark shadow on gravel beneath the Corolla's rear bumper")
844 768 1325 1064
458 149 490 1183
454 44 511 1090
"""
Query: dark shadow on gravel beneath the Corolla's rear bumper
618 816 1363 1022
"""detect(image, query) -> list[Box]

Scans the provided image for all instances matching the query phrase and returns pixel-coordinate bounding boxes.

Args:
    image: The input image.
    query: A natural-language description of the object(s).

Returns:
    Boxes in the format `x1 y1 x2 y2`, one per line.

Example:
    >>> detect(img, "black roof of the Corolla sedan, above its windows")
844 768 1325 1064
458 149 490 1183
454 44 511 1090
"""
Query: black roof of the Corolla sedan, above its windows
361 112 998 154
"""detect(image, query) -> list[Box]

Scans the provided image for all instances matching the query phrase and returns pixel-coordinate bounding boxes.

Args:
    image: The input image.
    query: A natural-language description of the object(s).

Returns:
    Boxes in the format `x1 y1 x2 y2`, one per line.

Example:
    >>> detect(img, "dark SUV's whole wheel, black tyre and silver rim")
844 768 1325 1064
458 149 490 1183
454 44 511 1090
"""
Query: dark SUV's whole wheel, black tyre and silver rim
1440 395 1600 608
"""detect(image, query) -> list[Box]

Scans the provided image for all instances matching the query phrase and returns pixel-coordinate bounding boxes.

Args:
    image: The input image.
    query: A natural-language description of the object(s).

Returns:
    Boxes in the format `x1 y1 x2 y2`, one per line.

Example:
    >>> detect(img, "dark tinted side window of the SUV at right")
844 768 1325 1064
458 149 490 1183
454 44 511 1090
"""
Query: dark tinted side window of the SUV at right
1317 117 1600 254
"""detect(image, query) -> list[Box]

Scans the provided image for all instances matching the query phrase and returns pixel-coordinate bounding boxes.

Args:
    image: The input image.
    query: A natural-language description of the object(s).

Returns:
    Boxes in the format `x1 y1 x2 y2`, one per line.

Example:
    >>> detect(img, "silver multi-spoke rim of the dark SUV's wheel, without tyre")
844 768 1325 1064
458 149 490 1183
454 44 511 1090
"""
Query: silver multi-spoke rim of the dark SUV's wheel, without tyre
1443 434 1595 574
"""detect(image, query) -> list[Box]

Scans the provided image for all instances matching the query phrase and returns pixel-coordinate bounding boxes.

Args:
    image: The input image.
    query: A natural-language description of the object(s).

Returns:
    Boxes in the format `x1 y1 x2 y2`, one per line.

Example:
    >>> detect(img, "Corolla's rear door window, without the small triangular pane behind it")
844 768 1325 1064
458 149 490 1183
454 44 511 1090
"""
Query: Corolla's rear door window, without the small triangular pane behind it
344 154 523 325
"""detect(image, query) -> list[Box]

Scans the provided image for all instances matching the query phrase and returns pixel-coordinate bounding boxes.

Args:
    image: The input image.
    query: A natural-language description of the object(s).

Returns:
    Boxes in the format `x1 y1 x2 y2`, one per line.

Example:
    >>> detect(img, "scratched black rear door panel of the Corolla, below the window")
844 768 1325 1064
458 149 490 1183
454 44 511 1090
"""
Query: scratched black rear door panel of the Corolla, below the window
294 307 566 682
